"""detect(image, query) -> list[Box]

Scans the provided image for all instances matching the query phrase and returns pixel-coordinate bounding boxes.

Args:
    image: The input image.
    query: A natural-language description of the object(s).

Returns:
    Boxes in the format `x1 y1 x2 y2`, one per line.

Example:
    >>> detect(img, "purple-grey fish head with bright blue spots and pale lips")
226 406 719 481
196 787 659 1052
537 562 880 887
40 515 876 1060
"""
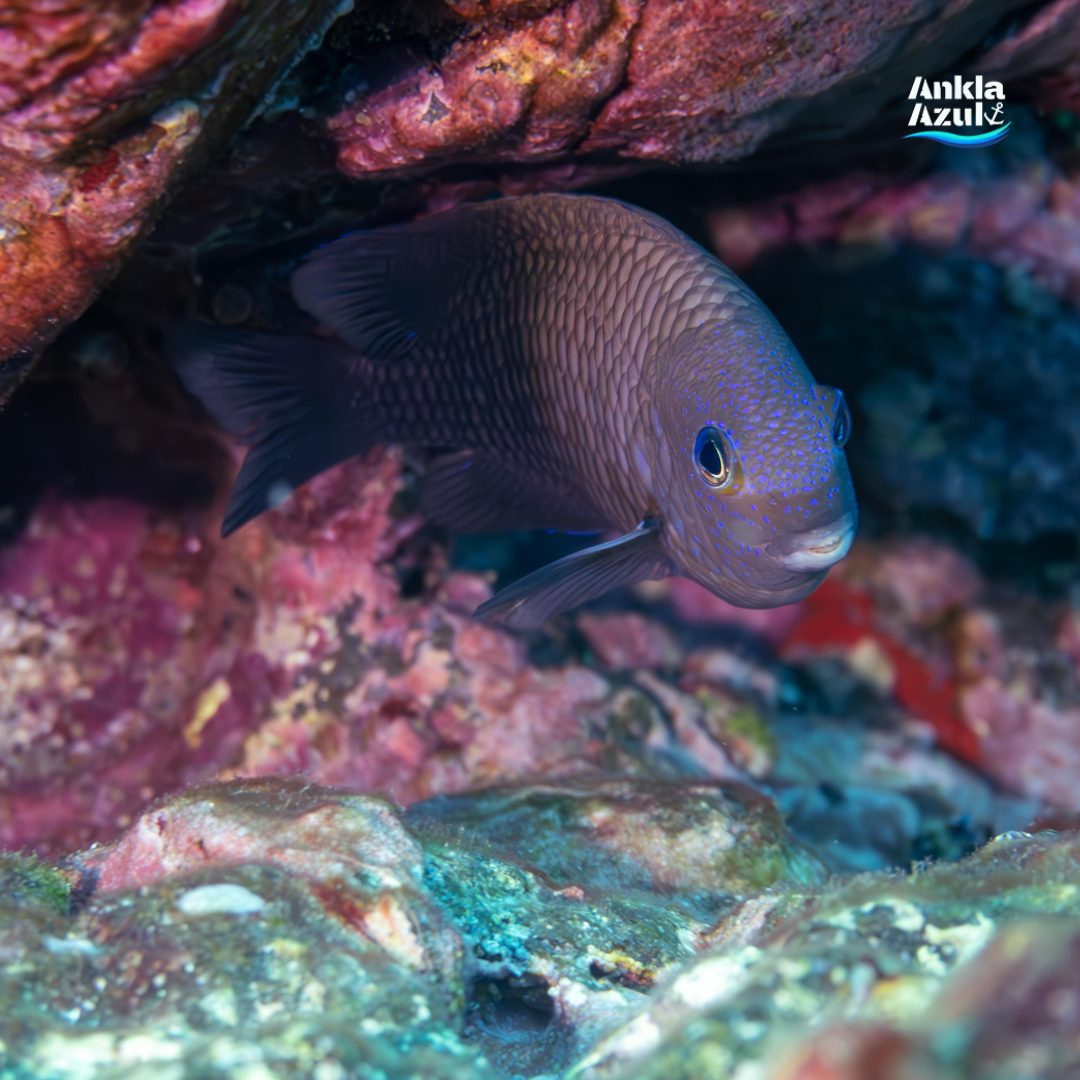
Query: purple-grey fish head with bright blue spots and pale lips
652 315 858 608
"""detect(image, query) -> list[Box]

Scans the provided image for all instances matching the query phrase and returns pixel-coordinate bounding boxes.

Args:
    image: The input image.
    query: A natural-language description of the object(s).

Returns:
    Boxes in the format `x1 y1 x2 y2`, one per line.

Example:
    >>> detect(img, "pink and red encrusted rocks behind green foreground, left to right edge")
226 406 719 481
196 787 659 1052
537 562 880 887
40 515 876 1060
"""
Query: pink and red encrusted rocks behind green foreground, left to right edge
0 442 1077 851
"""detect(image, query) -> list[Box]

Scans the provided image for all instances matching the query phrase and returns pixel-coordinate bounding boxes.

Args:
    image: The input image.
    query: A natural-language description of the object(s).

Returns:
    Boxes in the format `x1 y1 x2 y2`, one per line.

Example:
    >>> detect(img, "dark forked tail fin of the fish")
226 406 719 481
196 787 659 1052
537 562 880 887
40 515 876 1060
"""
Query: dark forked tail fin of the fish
165 323 380 536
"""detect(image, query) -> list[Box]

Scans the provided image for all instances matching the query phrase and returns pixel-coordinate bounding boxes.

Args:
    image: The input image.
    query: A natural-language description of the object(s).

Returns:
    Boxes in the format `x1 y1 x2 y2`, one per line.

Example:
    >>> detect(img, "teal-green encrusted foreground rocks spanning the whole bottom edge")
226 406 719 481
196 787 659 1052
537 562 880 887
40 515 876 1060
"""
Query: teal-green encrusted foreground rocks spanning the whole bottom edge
0 780 1080 1078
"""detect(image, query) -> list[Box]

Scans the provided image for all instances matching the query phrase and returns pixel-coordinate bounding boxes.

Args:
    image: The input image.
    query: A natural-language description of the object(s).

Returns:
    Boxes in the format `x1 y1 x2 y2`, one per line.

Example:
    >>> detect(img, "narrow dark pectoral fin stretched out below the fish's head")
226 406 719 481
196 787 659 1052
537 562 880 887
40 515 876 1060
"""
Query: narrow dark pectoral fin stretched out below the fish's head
476 522 671 630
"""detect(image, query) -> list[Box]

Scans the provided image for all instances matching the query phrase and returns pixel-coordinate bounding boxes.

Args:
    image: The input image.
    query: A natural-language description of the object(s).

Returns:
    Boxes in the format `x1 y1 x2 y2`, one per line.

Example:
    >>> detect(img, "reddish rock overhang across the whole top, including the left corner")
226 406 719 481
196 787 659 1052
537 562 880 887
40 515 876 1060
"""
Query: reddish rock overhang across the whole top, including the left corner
0 0 1080 367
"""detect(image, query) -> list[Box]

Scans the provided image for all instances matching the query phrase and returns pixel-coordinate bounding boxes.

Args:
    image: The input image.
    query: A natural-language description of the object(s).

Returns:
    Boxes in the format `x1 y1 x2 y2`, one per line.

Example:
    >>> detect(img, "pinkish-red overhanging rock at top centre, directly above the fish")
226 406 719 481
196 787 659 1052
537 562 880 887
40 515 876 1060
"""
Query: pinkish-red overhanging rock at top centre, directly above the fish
327 0 1036 176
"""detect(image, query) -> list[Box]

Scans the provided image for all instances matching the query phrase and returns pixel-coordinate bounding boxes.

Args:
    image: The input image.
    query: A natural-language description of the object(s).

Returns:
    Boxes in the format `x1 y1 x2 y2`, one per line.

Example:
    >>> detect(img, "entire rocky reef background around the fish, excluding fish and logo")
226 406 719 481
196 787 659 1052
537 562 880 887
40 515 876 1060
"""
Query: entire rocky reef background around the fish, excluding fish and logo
0 0 1080 1080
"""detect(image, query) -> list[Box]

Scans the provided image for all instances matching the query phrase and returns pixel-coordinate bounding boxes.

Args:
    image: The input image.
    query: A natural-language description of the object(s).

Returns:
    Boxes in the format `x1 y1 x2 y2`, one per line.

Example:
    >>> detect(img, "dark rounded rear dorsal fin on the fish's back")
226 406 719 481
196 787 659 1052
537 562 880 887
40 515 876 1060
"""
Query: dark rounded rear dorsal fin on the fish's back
292 207 472 360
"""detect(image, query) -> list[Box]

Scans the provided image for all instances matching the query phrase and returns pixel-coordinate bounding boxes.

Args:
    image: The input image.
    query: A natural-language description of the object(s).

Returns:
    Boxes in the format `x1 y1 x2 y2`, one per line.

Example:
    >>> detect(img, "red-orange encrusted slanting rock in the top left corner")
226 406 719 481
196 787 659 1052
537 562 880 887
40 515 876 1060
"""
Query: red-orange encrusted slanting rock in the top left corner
0 0 347 375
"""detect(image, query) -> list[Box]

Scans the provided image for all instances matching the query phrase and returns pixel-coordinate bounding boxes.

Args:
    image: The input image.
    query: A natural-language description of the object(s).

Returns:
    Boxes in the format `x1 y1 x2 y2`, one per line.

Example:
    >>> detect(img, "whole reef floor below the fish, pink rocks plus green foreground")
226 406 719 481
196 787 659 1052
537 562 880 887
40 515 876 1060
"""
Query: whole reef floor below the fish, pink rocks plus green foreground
0 434 1080 1078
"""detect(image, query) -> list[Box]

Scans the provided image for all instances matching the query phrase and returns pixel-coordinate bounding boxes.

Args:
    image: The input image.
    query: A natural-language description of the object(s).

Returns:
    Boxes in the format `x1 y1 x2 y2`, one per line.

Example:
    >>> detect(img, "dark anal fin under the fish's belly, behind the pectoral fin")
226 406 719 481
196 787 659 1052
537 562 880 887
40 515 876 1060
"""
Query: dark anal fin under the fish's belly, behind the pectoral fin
421 450 604 532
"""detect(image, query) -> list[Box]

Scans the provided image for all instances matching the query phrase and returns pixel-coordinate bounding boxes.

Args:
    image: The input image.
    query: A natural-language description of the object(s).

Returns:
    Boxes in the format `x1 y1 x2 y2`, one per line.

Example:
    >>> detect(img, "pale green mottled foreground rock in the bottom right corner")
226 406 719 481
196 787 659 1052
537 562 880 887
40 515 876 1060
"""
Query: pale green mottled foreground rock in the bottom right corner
576 834 1080 1080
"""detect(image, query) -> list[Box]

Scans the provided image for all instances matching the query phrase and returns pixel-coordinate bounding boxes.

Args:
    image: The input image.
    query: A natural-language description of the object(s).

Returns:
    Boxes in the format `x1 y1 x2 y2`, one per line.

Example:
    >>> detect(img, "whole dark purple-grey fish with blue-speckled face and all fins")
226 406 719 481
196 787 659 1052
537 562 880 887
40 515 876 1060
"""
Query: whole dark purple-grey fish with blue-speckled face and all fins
170 195 856 626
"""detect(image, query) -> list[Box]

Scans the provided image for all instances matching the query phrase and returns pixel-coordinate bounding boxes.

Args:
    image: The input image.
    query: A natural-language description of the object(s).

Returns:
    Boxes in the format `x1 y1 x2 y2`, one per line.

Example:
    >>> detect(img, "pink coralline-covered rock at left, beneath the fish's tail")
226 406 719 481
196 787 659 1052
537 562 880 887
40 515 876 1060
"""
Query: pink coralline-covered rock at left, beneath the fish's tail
0 453 662 850
